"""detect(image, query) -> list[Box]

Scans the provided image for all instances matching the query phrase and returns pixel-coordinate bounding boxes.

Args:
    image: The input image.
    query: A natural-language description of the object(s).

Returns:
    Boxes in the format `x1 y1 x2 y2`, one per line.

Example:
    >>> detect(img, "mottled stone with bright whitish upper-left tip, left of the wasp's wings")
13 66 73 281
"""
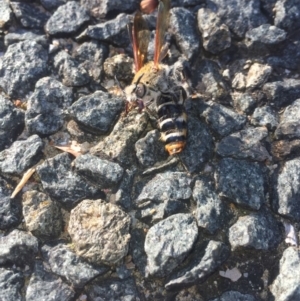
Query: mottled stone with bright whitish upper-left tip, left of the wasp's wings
53 50 90 87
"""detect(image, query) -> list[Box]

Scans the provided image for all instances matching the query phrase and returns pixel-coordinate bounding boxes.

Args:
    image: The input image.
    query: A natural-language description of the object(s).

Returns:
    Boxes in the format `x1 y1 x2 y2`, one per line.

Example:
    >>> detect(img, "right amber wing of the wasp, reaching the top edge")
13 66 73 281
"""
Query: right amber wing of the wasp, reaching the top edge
154 0 170 67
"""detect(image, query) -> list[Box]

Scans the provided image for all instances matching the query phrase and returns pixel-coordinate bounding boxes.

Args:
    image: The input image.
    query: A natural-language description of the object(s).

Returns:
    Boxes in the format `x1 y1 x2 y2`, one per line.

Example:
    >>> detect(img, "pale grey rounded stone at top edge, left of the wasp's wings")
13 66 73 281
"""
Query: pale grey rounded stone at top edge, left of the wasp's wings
45 1 90 35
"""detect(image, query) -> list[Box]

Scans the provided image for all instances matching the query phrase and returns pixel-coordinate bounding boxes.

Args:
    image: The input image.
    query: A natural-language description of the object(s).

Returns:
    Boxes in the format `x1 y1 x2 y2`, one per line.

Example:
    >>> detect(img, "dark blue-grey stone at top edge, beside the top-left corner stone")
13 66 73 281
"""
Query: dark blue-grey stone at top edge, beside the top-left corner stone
10 1 49 28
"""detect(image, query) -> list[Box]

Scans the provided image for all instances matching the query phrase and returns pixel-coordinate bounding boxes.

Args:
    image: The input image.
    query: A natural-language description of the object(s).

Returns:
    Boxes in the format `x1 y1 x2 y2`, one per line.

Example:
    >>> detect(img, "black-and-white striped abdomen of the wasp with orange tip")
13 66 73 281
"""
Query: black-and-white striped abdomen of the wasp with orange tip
156 93 187 155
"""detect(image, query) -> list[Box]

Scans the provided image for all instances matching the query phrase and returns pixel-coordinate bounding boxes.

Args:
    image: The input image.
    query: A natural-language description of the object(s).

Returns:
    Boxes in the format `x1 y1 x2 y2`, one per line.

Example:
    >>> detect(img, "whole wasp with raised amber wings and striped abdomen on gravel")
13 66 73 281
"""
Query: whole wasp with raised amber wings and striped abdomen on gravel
124 0 187 155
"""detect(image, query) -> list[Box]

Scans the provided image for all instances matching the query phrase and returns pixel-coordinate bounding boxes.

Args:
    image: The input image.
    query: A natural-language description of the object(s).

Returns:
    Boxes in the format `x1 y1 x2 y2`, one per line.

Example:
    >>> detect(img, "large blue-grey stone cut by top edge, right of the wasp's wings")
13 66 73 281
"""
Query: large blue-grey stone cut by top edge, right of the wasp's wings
207 0 267 38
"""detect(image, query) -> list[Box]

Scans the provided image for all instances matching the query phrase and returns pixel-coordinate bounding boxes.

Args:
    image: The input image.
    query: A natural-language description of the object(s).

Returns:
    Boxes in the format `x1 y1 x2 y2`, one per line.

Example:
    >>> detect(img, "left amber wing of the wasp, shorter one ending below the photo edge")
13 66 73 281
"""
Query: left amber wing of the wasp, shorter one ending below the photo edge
129 11 150 72
